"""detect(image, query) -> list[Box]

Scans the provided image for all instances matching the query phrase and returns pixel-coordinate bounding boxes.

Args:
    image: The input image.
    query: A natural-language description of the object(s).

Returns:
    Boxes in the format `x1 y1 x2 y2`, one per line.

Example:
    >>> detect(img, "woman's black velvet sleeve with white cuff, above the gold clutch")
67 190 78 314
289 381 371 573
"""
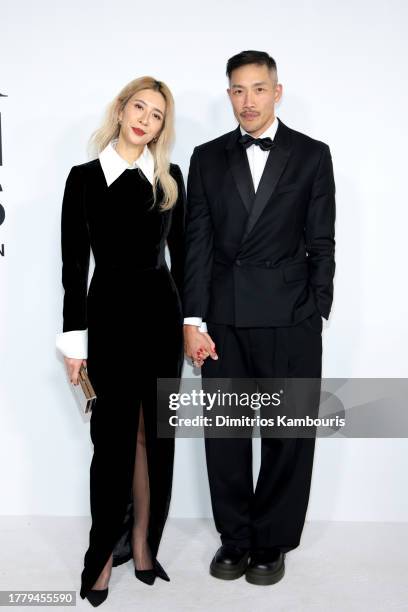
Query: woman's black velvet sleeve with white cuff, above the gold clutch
57 166 90 358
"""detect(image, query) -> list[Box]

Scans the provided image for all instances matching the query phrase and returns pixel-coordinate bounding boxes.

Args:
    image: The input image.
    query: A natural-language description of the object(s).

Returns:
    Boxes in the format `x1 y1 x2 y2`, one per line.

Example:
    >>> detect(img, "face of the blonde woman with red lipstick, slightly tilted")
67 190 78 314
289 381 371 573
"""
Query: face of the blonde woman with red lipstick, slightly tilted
119 89 166 145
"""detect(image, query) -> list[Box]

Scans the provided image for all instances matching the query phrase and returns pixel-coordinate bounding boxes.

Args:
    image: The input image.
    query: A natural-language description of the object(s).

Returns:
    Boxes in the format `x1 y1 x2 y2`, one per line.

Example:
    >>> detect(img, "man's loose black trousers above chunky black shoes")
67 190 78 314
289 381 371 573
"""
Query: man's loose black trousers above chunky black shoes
202 312 322 552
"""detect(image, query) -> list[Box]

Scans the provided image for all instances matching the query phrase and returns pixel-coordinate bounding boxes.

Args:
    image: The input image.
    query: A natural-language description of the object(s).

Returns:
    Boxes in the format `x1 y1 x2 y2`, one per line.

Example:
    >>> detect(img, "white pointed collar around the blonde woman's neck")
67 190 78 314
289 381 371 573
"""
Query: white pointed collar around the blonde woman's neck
98 138 154 187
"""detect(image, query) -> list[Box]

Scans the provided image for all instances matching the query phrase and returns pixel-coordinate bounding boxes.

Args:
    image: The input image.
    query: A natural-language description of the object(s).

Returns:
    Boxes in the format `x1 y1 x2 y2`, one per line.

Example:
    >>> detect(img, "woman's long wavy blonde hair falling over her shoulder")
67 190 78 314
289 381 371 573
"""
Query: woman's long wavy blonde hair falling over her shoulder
88 76 178 210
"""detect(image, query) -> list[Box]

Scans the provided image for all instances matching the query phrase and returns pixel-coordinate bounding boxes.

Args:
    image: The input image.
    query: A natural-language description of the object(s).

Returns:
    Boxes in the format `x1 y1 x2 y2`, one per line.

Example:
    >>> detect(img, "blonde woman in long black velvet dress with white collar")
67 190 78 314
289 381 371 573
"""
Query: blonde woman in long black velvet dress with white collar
57 77 186 606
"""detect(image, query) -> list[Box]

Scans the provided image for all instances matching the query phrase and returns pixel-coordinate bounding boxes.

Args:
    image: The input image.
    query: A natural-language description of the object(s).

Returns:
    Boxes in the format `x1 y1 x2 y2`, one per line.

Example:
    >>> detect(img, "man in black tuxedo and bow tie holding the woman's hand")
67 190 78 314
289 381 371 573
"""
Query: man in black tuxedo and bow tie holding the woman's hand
183 51 335 584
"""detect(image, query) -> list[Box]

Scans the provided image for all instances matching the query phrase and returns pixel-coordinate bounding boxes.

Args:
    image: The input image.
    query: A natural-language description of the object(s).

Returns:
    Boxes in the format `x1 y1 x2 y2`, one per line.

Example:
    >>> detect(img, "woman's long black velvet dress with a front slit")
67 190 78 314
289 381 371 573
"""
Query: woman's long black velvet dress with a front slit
61 159 185 598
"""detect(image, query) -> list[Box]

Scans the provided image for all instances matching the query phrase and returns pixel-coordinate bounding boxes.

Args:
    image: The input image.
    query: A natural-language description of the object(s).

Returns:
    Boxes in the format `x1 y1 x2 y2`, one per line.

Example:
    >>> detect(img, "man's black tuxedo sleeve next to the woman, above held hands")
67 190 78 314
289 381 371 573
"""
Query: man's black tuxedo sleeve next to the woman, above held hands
183 147 214 319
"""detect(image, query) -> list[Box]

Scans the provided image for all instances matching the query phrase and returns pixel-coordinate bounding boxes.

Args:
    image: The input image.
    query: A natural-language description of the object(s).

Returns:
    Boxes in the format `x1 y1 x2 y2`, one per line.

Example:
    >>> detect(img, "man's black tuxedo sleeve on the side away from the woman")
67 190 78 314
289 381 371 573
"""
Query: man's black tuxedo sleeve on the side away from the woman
305 144 336 319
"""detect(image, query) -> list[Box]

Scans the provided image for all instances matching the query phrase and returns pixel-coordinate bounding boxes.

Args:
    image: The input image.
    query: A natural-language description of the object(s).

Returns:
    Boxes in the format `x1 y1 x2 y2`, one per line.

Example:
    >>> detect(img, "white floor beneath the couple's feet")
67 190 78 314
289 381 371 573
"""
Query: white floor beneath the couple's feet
0 517 408 612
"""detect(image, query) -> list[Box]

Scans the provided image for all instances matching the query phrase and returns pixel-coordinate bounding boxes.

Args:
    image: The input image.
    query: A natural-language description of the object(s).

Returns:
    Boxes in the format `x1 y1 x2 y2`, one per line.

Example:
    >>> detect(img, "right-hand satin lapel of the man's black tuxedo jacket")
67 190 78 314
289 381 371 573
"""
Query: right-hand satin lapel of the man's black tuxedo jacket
242 119 291 241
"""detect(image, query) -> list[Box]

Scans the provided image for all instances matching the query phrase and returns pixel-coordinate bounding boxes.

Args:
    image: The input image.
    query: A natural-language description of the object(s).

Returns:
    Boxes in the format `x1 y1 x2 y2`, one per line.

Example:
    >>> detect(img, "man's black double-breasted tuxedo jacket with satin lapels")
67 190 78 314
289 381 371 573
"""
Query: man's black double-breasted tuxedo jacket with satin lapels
183 119 335 327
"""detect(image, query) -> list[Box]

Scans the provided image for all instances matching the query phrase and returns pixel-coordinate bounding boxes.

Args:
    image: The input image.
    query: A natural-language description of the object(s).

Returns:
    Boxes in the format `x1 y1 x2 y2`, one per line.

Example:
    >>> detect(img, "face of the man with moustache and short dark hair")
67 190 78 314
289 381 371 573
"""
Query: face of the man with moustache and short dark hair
227 64 282 138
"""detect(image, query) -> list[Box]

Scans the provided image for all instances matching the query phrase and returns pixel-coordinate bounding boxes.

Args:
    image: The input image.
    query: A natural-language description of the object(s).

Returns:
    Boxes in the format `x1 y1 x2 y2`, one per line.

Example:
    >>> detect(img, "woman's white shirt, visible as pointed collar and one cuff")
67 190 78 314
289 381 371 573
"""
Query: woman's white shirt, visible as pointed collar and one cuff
56 138 158 359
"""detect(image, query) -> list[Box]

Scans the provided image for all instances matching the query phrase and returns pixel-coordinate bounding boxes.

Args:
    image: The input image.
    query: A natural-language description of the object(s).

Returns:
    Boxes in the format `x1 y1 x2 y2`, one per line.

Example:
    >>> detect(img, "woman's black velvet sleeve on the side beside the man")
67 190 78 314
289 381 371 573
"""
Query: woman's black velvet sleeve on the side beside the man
167 165 186 300
